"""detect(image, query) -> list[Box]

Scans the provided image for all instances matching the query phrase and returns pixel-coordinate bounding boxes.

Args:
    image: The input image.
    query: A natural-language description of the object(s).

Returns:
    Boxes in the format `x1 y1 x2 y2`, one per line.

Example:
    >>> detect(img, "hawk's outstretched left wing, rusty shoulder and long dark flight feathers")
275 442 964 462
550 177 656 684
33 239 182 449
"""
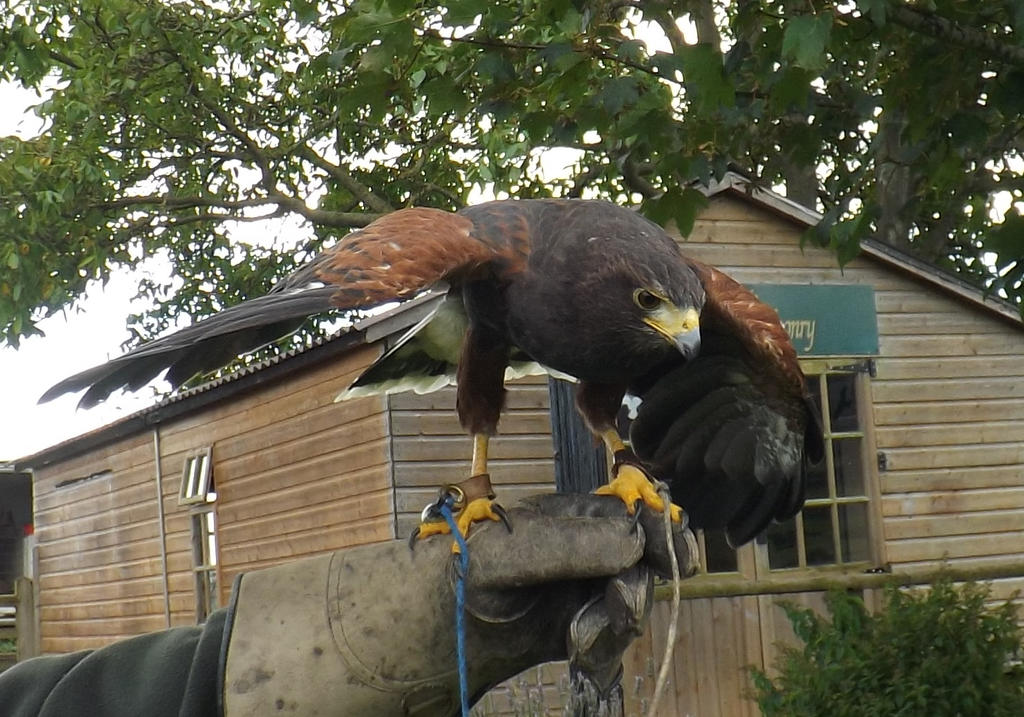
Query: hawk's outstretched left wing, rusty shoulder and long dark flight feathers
40 208 528 408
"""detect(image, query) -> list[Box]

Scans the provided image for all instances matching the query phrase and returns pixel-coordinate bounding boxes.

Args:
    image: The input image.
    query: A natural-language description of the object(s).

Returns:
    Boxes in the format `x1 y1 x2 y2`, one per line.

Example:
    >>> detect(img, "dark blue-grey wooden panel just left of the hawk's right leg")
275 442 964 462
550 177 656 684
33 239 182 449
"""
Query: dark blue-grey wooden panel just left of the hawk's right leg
548 378 607 493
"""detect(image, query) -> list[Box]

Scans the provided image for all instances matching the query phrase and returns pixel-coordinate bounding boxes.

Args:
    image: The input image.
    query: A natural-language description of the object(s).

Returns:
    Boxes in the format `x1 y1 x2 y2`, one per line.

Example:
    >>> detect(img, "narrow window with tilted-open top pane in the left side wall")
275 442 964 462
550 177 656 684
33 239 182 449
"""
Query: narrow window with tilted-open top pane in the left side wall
178 447 220 623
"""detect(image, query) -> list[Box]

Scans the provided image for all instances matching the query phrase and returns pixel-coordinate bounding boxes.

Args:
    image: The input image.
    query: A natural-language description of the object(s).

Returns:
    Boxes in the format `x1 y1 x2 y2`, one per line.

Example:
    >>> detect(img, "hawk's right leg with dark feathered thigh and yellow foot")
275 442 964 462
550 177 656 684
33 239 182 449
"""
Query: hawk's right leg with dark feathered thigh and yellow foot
575 381 683 522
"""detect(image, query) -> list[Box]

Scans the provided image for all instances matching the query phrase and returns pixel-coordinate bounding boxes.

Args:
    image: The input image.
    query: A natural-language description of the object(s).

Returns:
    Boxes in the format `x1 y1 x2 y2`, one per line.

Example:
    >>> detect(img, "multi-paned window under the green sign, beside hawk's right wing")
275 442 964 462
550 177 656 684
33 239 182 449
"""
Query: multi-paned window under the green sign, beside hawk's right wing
764 361 873 570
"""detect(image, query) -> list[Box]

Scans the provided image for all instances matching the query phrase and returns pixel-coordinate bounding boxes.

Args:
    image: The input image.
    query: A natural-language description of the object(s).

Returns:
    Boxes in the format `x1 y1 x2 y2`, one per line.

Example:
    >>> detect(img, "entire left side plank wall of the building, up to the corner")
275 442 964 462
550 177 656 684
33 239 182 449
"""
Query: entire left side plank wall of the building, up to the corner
29 347 394 652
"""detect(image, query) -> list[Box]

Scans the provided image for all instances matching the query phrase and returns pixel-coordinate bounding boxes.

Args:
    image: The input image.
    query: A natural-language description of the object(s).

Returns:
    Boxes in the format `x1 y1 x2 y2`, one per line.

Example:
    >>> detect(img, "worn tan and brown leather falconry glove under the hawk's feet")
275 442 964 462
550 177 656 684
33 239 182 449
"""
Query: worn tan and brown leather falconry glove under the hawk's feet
223 495 697 717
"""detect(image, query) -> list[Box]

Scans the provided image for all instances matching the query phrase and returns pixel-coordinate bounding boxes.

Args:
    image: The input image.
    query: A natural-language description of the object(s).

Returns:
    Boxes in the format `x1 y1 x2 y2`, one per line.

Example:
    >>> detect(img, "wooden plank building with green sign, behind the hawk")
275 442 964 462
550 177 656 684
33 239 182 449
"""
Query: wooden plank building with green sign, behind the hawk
17 176 1024 717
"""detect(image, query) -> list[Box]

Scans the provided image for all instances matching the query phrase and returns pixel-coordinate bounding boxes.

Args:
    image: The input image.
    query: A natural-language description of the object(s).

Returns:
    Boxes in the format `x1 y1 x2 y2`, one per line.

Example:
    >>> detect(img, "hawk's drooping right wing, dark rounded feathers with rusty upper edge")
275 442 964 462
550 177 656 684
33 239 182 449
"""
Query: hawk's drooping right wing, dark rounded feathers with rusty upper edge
631 260 823 545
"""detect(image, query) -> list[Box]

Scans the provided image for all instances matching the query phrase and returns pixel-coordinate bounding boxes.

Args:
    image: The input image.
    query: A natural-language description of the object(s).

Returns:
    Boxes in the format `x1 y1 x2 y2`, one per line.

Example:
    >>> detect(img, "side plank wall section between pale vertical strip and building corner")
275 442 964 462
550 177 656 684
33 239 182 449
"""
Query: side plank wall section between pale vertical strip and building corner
161 346 393 625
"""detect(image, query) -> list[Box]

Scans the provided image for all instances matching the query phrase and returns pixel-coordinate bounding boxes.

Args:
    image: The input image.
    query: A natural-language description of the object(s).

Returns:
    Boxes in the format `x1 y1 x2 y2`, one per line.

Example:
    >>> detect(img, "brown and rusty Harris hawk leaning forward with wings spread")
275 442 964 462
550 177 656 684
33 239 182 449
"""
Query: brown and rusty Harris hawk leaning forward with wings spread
41 200 822 545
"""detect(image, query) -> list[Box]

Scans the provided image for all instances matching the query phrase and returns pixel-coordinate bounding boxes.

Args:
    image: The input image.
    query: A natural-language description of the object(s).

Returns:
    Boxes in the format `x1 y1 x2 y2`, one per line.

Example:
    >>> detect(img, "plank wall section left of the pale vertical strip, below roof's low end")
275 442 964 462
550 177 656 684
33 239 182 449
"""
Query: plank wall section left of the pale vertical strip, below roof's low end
34 432 165 652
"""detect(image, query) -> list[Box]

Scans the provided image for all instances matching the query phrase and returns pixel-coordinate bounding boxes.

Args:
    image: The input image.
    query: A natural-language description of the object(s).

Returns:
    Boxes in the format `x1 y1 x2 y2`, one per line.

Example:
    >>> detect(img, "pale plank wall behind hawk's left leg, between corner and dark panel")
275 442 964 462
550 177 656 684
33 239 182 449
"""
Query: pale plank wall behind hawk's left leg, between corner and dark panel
388 376 555 536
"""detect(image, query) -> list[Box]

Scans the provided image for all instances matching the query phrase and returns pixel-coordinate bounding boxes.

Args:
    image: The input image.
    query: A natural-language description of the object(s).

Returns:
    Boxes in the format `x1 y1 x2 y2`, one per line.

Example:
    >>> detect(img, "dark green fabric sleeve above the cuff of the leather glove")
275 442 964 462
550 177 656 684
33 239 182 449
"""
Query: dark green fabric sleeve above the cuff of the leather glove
0 610 226 717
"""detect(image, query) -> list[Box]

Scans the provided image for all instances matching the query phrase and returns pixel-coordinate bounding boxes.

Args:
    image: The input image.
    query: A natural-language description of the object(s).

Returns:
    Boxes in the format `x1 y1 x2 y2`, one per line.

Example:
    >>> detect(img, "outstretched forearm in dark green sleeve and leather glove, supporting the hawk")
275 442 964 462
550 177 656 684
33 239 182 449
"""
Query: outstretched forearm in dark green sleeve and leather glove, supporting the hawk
0 495 697 717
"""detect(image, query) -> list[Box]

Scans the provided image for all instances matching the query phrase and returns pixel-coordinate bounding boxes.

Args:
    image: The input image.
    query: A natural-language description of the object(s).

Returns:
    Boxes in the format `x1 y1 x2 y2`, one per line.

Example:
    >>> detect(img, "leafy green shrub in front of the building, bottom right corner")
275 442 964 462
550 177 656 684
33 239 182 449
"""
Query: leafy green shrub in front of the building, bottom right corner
751 580 1024 717
